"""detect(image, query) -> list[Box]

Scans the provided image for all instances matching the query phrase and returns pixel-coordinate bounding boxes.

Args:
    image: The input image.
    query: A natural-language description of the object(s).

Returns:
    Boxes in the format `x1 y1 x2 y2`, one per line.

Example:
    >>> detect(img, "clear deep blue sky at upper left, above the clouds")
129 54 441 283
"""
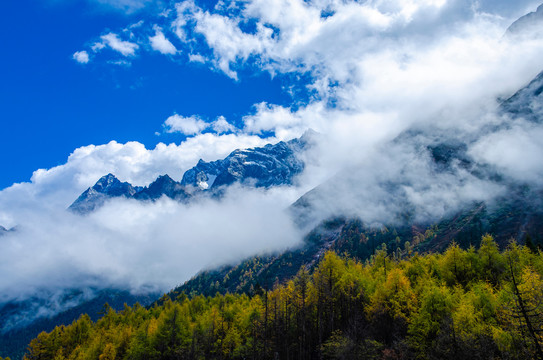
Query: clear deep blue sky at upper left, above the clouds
0 0 298 189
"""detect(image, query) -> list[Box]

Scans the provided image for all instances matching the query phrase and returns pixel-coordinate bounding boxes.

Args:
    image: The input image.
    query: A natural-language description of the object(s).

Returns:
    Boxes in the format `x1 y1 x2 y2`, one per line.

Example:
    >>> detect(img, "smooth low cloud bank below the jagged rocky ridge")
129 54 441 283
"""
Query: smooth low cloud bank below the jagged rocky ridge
0 184 299 302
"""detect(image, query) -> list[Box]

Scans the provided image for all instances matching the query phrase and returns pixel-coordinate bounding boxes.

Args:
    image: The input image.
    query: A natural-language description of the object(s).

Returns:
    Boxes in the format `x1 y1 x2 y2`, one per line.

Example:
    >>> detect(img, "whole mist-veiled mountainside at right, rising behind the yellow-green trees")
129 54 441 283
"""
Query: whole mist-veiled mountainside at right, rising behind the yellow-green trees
175 67 543 298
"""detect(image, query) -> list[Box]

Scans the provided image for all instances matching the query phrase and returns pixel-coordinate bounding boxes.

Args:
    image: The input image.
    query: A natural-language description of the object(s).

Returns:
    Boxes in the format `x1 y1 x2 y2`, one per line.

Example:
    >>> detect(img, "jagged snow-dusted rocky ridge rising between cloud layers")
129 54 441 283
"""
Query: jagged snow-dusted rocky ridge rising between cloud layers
69 130 317 214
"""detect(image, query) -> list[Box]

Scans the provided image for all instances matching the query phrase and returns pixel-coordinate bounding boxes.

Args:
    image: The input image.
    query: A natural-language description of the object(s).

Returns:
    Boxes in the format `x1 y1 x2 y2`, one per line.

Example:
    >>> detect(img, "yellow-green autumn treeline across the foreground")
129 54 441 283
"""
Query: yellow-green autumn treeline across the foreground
25 236 543 360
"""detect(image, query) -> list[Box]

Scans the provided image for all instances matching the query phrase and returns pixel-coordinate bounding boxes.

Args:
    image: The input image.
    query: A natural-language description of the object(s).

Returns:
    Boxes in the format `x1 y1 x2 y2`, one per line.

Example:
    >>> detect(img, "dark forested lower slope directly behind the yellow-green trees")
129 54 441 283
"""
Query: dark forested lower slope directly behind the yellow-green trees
169 184 543 299
